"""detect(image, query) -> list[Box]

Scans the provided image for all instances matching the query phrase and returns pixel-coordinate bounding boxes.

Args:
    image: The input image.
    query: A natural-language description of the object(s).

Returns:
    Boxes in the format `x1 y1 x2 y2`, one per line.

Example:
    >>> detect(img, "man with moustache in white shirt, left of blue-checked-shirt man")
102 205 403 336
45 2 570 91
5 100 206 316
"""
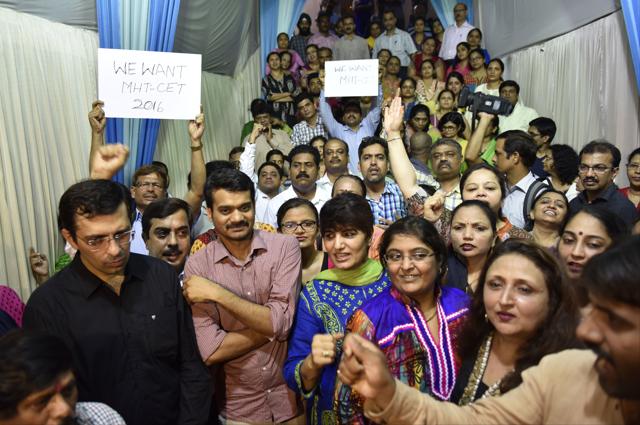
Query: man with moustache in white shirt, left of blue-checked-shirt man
265 145 331 228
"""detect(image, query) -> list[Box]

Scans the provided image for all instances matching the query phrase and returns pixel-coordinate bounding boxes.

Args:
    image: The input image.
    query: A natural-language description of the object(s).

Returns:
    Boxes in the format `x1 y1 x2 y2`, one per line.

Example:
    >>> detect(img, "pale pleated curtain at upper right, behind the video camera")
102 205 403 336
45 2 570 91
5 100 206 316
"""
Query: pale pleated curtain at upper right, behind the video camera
503 11 640 185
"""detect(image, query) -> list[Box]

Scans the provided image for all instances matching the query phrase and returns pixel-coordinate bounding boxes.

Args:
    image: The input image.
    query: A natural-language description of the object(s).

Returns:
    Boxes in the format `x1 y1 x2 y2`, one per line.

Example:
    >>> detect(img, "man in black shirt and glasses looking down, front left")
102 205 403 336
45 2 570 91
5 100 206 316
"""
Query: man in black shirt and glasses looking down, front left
24 180 212 425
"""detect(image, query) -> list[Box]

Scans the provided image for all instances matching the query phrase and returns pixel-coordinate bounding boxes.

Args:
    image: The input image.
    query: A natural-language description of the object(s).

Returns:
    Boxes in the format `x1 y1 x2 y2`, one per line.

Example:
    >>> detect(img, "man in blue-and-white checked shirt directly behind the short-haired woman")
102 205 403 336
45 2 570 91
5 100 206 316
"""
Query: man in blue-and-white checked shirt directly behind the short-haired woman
358 137 407 227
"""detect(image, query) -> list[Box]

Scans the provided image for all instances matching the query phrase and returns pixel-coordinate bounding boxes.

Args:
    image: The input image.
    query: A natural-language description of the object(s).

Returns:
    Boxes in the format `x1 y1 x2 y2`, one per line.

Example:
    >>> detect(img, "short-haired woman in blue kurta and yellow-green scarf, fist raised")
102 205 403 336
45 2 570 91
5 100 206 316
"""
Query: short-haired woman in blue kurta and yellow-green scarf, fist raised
284 193 389 424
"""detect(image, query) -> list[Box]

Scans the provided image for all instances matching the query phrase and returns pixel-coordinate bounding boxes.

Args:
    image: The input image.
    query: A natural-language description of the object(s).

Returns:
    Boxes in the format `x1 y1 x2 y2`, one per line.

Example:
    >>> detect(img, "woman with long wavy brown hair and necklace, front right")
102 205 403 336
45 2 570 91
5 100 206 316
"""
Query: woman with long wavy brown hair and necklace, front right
451 240 580 405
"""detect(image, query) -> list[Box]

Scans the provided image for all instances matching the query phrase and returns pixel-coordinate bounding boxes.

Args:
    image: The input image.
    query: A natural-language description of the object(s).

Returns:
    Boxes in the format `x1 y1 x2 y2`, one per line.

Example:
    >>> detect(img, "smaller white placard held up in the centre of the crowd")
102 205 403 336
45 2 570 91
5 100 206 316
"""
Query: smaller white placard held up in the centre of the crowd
324 59 378 97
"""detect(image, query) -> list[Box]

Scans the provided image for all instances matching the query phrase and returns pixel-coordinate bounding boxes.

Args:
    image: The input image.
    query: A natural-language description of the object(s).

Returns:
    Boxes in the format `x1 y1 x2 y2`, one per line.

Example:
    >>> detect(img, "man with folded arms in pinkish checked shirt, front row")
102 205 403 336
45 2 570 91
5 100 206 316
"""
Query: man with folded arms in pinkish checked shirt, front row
183 167 300 423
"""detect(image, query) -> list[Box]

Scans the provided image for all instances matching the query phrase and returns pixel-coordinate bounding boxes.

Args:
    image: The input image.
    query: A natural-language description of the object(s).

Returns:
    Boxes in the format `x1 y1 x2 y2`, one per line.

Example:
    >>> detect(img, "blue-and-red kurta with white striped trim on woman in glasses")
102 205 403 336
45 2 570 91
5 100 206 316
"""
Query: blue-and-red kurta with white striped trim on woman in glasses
334 286 469 424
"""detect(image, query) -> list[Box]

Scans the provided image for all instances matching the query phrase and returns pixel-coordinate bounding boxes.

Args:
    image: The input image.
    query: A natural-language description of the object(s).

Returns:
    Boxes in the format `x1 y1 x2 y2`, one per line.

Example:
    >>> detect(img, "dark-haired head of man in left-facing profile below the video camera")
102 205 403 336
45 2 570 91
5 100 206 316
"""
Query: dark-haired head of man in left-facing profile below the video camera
494 130 538 174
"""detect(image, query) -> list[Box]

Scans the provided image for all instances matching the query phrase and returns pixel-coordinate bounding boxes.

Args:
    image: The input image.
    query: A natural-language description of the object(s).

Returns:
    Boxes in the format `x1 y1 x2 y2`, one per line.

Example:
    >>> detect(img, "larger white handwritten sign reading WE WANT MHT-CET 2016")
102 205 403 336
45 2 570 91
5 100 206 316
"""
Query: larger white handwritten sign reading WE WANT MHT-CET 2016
98 49 202 119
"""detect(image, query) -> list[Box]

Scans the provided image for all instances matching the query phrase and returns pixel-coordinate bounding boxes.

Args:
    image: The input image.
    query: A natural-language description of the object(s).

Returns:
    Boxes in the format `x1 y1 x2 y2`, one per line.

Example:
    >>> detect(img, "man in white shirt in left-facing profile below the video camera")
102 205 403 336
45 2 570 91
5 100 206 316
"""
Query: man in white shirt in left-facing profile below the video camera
494 131 546 229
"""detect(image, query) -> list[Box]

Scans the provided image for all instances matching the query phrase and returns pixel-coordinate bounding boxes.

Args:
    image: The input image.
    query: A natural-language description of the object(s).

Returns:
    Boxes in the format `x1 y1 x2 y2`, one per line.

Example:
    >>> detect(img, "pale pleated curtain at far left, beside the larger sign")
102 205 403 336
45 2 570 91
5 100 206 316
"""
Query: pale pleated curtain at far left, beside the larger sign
0 8 98 300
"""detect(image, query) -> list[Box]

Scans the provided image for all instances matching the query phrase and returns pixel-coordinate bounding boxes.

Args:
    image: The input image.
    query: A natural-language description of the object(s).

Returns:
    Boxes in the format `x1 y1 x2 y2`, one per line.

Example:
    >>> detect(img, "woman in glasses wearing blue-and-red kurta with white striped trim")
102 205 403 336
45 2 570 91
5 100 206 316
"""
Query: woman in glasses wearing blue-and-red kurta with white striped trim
335 217 469 424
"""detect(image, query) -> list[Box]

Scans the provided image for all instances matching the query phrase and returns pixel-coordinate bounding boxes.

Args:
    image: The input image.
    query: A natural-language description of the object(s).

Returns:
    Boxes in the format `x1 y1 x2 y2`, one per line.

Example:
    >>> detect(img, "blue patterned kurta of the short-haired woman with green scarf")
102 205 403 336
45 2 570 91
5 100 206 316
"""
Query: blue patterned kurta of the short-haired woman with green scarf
284 271 390 425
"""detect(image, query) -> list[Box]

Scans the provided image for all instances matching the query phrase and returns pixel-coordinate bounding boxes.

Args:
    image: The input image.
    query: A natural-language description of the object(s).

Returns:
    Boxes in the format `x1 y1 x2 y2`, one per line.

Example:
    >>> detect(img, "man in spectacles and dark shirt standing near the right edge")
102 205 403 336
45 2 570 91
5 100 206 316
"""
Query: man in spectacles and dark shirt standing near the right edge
569 139 638 227
